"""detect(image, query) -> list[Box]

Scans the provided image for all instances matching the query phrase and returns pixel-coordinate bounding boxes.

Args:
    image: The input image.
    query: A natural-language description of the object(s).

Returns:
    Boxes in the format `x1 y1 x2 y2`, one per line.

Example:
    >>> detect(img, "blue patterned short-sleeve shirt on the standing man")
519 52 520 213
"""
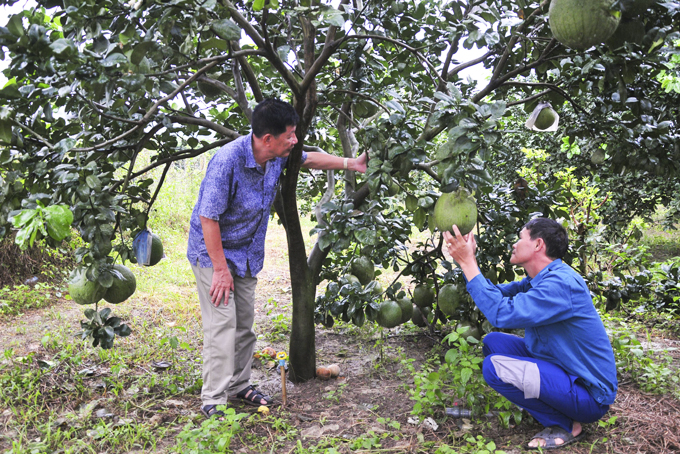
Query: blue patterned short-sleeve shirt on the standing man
187 133 307 277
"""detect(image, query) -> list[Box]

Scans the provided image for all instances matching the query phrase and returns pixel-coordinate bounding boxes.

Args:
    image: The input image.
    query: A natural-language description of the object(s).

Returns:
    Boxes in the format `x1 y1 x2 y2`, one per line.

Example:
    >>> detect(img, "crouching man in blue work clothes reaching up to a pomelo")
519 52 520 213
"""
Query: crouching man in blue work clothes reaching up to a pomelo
444 218 618 449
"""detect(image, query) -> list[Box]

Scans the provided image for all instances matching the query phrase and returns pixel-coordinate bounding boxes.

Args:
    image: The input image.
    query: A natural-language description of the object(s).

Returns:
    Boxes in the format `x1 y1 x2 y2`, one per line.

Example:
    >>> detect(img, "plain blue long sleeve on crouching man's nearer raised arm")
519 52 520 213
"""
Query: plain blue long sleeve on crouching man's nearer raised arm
467 274 573 329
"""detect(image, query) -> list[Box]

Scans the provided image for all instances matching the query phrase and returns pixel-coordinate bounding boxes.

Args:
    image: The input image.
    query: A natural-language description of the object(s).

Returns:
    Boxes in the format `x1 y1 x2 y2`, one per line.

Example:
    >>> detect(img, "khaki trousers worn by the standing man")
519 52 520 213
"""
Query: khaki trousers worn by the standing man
191 265 257 405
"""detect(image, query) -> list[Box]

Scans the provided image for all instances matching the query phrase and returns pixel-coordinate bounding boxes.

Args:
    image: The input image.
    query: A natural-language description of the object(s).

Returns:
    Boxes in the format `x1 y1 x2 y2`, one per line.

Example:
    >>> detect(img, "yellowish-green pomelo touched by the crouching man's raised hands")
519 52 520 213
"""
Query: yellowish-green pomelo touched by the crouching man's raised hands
434 188 477 235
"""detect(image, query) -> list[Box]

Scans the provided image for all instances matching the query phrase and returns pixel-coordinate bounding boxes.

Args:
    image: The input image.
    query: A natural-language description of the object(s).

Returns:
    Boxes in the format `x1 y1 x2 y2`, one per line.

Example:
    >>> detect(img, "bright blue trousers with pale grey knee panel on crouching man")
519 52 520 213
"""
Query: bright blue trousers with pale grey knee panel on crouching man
482 332 609 432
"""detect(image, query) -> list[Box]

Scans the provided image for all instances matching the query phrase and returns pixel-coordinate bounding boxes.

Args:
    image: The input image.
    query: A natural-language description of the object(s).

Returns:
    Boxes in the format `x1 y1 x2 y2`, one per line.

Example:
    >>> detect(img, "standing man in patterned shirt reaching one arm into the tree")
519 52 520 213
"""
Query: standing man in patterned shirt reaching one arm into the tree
187 99 368 417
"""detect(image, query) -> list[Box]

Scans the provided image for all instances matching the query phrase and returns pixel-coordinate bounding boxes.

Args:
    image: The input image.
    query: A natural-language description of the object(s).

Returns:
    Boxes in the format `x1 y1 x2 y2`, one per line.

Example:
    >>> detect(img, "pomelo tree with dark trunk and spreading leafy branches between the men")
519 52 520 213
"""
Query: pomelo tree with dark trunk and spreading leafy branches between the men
0 0 680 380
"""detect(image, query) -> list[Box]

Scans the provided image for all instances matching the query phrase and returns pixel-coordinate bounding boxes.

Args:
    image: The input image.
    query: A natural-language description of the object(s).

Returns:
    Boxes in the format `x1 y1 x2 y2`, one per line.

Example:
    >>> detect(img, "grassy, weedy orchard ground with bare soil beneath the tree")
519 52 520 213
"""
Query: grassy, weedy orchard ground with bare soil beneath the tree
0 286 678 454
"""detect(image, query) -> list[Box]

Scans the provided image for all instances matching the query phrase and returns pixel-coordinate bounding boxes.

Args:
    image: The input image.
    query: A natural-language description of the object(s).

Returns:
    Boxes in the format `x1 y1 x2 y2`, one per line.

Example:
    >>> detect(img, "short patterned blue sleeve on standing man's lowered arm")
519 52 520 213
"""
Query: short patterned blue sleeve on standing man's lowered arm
198 155 234 221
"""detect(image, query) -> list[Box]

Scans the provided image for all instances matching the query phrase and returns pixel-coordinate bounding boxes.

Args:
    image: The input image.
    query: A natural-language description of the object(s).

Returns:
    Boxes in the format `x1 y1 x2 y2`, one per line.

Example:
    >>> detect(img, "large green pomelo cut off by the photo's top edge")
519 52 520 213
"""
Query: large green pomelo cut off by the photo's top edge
548 0 621 50
